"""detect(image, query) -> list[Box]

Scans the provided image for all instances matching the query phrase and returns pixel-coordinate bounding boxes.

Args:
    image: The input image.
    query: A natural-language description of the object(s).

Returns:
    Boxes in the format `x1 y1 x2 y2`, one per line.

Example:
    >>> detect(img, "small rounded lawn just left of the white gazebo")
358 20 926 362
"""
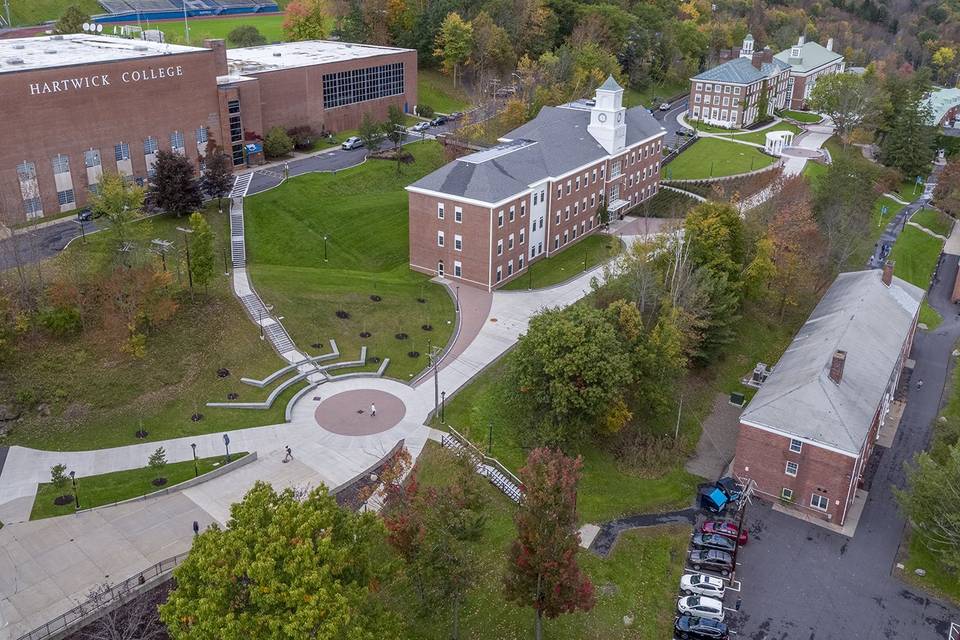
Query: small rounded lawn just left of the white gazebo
661 138 774 180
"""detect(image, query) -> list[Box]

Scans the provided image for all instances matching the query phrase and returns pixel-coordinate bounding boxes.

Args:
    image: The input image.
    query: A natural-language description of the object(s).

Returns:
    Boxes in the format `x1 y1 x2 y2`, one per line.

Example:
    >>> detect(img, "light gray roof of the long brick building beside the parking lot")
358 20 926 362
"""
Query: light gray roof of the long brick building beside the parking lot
741 270 924 455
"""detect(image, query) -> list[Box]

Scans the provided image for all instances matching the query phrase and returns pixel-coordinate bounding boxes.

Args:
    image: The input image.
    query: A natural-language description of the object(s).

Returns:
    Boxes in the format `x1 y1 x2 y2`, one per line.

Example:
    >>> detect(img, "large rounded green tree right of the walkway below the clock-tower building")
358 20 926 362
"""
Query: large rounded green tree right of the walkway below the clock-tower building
514 305 630 446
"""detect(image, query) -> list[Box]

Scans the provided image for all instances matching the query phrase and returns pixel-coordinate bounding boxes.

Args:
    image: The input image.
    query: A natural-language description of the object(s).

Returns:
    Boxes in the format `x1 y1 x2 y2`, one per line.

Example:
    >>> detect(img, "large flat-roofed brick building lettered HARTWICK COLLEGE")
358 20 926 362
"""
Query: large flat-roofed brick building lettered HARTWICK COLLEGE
0 34 417 224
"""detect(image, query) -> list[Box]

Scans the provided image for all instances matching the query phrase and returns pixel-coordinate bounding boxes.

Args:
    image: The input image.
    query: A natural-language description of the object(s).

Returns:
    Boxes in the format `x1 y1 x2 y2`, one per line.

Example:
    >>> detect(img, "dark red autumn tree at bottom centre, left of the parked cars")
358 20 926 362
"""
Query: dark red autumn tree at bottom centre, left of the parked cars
505 447 594 640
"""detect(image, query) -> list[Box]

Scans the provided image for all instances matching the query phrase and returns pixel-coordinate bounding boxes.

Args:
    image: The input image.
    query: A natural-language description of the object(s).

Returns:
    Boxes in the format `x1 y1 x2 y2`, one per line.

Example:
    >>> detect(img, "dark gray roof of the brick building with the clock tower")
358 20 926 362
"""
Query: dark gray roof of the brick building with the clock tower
410 107 664 203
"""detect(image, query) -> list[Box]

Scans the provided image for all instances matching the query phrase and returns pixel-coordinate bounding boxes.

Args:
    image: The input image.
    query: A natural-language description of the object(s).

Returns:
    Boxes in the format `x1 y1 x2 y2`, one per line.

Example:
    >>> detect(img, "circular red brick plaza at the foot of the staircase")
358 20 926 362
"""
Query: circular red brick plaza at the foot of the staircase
313 389 407 436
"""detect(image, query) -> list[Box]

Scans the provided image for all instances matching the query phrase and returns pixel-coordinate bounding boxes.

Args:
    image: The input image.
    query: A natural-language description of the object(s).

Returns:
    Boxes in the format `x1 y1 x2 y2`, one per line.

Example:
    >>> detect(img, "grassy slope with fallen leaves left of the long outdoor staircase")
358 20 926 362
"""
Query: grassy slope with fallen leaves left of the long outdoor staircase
0 213 296 450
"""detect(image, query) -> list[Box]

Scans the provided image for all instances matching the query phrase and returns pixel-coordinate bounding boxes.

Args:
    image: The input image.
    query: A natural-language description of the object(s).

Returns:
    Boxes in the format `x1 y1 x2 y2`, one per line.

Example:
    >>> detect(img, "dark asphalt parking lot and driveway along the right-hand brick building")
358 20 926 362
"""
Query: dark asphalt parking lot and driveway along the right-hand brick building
737 256 960 640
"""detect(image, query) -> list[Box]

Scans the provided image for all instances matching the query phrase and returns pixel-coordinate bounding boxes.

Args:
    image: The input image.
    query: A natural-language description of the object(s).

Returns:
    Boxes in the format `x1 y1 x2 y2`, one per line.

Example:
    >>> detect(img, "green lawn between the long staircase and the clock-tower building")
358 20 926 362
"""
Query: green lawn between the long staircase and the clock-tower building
245 142 454 381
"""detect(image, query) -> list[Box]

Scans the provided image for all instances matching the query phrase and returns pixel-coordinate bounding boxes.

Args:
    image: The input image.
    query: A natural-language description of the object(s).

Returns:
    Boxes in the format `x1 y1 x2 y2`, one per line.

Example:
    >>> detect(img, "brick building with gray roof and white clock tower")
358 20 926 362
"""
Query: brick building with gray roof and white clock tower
407 77 666 291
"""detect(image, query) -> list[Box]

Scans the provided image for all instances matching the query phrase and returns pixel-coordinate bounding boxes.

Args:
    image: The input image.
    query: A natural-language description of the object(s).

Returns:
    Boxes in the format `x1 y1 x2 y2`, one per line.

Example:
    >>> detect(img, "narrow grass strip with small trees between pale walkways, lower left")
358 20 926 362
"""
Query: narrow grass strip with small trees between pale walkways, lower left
30 451 247 520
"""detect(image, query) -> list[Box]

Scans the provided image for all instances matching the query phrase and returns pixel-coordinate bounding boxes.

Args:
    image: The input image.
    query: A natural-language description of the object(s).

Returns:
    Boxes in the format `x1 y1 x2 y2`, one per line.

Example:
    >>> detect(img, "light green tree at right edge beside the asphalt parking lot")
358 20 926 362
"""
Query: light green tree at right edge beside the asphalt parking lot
895 444 960 571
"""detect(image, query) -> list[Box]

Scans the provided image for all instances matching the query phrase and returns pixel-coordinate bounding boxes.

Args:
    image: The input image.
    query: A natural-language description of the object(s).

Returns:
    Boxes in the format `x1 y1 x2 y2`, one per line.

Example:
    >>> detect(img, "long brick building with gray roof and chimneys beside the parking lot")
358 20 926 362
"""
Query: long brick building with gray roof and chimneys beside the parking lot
733 263 924 526
